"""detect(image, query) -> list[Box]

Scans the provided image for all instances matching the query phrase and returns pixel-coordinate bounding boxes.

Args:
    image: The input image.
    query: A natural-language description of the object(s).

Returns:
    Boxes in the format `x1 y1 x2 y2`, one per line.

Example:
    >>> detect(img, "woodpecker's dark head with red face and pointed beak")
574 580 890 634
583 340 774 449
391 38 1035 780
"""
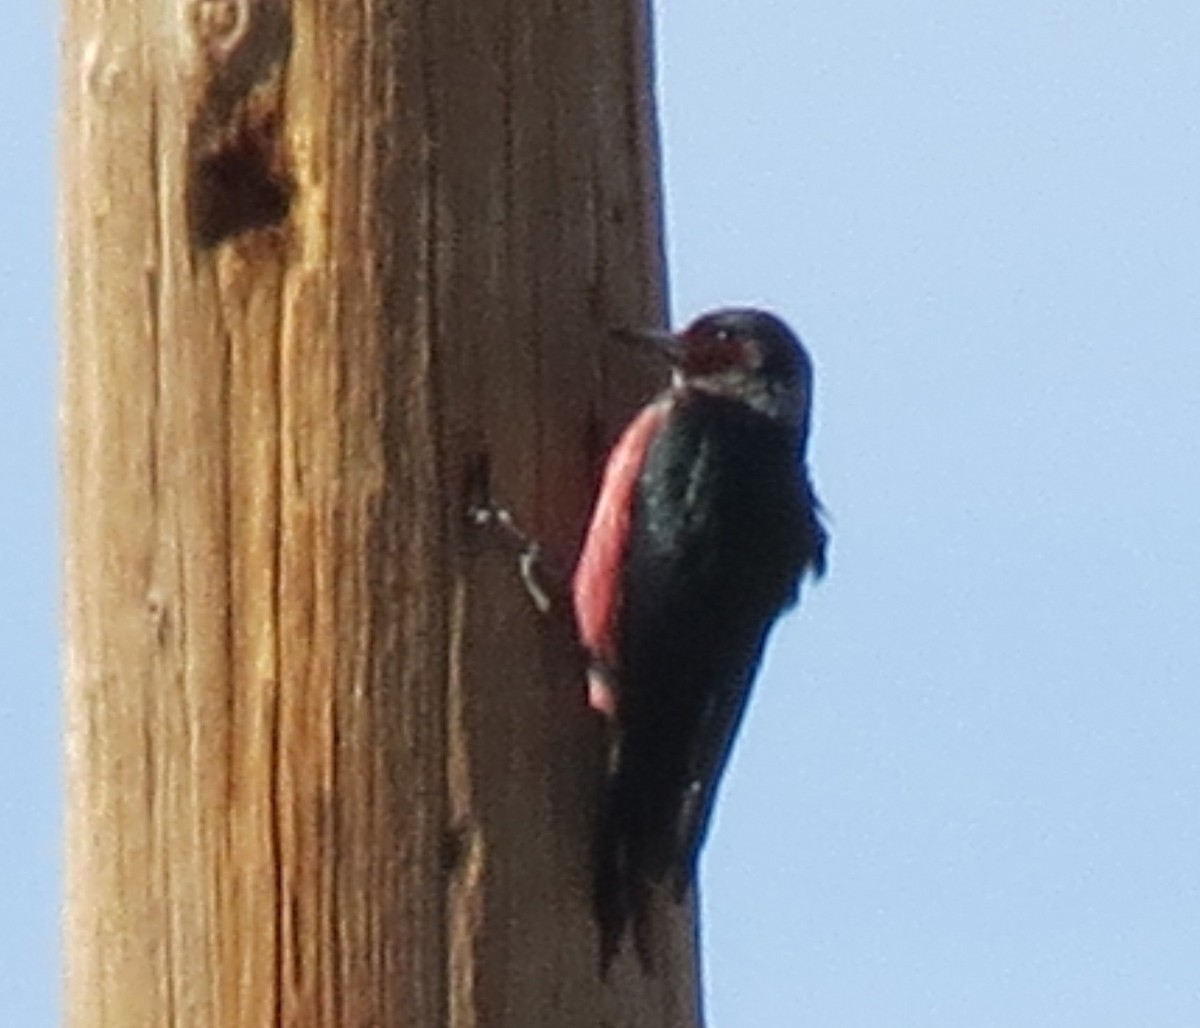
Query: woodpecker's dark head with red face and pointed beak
618 307 812 428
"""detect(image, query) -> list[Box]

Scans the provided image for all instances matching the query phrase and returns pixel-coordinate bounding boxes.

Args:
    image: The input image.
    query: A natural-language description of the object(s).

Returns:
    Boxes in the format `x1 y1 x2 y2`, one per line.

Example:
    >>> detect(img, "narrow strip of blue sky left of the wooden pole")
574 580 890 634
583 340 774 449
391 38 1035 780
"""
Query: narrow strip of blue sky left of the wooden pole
0 2 62 1028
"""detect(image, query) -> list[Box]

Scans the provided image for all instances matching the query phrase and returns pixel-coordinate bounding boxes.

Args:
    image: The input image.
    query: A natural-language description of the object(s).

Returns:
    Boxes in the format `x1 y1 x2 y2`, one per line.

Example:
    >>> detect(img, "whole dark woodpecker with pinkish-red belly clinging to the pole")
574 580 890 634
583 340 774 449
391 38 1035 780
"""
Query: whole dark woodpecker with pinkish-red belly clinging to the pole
571 308 827 968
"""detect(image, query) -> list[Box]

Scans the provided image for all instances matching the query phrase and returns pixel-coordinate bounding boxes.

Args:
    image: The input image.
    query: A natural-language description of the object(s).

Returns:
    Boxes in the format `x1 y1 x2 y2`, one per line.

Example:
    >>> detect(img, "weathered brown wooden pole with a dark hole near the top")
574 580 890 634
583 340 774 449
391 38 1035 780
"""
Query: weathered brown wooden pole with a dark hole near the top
62 0 698 1028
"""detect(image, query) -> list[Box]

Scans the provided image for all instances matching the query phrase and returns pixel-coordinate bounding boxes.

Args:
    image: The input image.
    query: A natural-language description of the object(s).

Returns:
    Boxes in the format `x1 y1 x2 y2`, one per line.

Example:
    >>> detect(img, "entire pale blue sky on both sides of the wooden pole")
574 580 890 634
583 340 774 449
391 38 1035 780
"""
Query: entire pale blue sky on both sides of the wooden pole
0 0 1200 1028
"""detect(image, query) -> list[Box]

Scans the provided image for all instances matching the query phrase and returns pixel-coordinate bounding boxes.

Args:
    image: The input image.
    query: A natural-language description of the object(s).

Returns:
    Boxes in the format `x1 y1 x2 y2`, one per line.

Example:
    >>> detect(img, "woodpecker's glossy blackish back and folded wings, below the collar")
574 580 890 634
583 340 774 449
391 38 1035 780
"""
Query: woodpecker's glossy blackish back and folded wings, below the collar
616 391 823 888
